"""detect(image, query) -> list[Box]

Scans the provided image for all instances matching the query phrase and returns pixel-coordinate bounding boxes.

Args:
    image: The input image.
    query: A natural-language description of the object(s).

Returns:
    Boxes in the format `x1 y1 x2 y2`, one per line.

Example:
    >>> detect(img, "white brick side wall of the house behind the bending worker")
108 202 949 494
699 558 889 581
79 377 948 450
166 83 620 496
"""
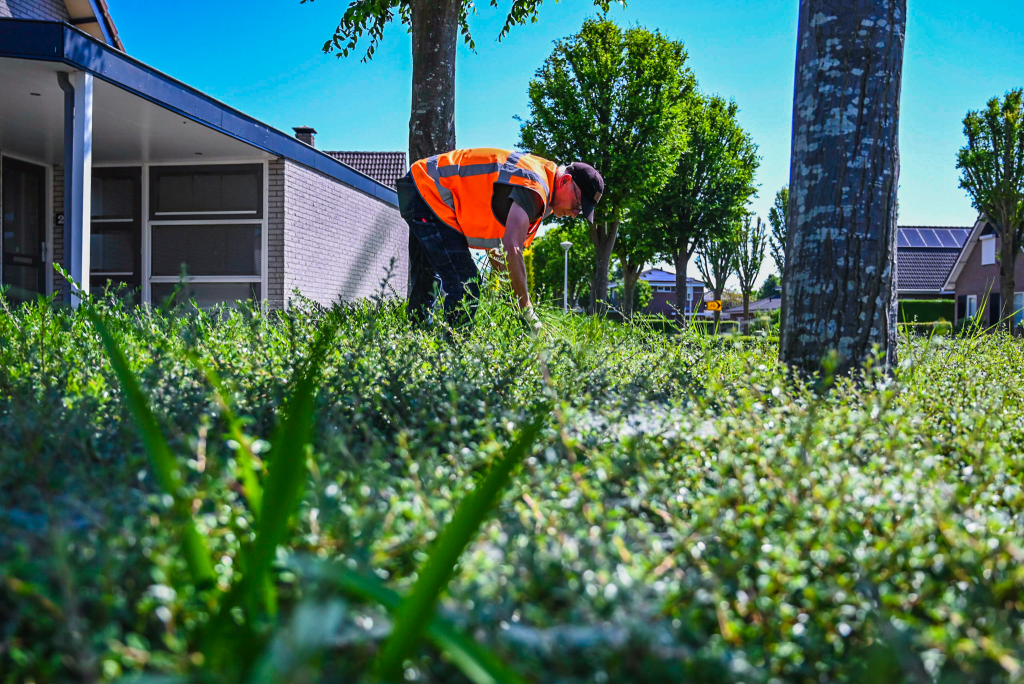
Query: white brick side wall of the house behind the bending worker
280 160 409 306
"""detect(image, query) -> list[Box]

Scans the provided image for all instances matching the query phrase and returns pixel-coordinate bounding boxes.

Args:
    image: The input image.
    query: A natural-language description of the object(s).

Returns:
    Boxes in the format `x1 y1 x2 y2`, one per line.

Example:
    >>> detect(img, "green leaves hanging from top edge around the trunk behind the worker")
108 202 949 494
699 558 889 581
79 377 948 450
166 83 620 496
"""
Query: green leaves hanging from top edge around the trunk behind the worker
300 0 626 61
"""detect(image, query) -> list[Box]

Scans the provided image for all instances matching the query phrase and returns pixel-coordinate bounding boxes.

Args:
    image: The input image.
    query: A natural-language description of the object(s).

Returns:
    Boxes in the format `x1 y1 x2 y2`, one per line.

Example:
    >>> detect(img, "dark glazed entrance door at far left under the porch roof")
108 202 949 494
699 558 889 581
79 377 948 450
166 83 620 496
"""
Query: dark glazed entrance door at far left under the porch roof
0 157 46 302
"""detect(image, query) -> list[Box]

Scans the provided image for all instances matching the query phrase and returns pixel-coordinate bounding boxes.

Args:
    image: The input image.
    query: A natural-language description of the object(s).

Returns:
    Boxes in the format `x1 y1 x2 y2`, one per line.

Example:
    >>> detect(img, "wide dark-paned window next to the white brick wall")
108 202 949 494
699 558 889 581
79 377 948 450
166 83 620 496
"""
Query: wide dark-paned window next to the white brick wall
148 164 266 308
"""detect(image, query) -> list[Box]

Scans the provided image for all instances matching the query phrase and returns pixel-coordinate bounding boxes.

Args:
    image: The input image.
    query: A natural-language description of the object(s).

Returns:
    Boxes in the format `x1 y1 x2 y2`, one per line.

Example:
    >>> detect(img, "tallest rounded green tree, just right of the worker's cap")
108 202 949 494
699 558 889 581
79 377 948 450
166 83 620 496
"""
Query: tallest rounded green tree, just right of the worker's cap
520 18 695 309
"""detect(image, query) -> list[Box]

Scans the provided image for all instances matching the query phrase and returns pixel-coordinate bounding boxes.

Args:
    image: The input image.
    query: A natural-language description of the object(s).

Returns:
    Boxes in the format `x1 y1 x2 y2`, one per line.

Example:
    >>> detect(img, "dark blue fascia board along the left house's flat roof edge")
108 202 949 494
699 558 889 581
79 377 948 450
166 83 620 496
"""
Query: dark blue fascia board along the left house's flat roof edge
0 18 398 207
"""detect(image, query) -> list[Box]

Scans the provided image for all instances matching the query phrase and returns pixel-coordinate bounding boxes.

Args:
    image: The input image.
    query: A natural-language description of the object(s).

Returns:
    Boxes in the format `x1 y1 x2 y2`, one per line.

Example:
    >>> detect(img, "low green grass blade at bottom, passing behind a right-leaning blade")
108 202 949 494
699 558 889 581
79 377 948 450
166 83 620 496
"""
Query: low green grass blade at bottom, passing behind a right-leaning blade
313 567 522 684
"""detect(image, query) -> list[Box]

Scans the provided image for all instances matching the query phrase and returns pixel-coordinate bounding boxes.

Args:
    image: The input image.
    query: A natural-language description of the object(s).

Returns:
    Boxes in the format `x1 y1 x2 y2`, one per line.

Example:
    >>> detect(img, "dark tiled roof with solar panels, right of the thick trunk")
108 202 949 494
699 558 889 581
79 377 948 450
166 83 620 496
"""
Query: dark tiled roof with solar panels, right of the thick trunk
896 225 971 293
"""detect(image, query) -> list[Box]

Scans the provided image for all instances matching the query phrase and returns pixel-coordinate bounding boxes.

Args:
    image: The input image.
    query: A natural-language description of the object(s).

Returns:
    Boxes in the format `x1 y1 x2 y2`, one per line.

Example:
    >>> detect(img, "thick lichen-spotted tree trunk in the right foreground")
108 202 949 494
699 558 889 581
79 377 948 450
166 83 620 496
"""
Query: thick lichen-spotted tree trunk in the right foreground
779 0 906 375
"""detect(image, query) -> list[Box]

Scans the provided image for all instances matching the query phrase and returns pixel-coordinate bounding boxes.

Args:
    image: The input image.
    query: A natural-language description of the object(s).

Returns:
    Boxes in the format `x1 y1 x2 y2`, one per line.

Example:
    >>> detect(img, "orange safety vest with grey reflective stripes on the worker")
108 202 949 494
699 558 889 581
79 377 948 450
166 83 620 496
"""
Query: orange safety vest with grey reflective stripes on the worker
412 147 558 250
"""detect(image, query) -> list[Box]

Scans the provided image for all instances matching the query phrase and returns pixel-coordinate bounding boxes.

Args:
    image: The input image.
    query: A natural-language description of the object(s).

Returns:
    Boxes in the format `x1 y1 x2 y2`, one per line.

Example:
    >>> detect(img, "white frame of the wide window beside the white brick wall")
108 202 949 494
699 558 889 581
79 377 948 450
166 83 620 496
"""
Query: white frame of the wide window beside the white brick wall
142 160 270 306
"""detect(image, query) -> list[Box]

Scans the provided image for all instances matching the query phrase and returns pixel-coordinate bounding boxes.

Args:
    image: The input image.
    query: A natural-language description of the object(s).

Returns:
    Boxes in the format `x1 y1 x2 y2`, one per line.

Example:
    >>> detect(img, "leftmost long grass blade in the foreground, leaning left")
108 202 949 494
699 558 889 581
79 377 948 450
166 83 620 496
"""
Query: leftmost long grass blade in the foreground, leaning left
85 307 216 587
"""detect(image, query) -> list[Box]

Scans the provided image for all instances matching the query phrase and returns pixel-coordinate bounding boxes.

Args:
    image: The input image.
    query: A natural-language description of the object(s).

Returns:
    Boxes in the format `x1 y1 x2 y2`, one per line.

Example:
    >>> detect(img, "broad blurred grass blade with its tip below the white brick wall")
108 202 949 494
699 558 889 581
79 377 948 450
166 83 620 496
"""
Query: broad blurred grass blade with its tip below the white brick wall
246 315 337 615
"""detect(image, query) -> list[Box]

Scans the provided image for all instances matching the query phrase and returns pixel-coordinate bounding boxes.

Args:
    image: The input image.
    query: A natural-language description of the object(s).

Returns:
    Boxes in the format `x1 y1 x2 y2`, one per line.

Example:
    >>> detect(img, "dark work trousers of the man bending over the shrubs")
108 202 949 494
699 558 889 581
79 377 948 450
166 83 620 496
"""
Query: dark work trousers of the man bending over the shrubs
397 172 480 328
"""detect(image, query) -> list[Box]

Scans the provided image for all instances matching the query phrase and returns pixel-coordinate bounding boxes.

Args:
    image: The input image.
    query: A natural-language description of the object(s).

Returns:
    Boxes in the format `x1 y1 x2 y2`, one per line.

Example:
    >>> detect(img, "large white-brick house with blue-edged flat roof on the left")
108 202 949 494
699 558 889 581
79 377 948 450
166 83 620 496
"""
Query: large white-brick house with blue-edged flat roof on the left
0 0 408 307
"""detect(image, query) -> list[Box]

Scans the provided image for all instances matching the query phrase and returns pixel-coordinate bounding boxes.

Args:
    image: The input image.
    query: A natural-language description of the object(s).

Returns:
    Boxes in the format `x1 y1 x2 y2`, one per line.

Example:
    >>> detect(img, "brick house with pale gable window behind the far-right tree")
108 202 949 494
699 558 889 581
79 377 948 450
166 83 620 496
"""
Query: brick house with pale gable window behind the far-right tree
943 217 1024 327
